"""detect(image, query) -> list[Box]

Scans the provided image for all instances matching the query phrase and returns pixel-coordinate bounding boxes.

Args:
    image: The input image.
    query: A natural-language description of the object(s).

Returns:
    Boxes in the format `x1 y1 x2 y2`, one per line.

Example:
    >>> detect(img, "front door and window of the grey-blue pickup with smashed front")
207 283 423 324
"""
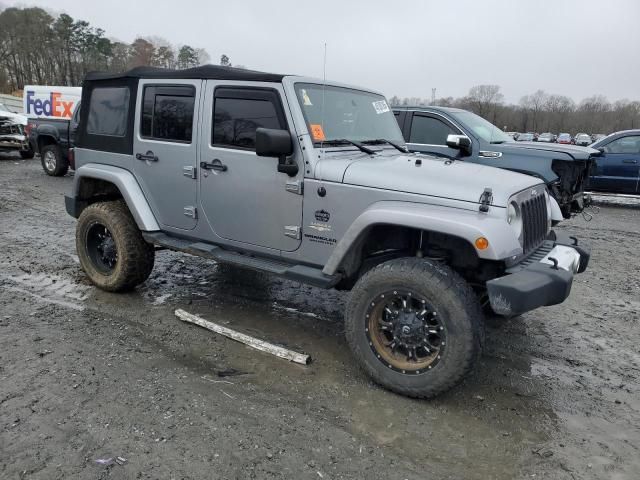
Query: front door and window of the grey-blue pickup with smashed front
404 112 462 158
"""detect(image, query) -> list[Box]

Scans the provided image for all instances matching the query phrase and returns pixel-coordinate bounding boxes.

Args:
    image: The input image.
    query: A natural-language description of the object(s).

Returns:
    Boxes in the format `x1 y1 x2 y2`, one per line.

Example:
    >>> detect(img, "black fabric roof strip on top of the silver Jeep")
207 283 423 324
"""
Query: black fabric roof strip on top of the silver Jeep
85 65 284 83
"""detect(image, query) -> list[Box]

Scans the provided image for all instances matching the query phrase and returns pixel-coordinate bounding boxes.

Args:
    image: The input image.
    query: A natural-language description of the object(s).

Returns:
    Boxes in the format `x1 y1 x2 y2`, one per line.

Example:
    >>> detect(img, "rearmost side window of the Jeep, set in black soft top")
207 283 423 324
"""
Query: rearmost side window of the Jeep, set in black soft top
87 87 129 137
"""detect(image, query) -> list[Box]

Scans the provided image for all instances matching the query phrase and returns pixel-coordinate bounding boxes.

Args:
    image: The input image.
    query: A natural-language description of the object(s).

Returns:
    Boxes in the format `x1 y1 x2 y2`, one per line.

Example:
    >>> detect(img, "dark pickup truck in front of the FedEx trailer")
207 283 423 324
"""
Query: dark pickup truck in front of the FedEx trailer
25 103 80 177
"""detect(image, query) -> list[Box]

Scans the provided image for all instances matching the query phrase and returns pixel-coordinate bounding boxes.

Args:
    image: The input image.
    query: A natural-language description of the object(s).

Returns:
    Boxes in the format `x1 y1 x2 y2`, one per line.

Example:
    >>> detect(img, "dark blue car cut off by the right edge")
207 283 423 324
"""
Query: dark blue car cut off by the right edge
591 135 640 193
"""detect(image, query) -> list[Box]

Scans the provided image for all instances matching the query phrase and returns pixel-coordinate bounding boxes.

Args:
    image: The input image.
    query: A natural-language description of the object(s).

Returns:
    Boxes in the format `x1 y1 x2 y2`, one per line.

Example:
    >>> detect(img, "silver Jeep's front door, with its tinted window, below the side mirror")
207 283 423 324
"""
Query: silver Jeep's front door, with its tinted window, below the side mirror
199 80 304 251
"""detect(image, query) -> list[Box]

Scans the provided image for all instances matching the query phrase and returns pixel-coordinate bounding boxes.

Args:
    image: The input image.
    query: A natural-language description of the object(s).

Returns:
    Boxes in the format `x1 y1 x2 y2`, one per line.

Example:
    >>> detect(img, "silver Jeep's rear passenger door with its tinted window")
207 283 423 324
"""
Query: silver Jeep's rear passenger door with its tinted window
133 80 203 230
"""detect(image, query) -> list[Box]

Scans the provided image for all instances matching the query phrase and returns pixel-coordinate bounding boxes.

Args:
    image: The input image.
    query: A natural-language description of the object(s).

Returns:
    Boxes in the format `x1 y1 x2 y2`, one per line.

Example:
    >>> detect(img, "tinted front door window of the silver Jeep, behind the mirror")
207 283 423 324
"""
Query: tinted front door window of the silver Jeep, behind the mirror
212 89 287 150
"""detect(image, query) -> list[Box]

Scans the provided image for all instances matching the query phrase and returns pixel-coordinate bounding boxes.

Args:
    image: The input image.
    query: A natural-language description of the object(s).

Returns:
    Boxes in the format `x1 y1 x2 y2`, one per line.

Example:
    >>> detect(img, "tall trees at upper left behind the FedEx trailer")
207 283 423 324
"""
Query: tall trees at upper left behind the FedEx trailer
0 7 238 93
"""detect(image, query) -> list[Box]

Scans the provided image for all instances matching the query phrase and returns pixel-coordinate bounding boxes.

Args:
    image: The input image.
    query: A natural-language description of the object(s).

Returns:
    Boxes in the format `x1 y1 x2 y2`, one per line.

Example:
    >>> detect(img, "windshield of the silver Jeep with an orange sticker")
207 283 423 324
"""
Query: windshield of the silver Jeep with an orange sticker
296 83 404 144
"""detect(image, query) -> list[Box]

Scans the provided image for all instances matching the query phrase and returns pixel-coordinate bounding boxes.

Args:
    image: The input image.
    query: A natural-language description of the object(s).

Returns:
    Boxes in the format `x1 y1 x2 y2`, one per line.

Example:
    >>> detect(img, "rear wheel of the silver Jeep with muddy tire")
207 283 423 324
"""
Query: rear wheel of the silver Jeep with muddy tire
76 201 155 292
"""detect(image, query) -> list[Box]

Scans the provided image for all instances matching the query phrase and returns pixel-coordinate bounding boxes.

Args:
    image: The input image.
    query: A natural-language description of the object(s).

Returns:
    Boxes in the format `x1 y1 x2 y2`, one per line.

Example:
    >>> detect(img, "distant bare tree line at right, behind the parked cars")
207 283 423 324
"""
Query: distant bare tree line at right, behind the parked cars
389 85 640 135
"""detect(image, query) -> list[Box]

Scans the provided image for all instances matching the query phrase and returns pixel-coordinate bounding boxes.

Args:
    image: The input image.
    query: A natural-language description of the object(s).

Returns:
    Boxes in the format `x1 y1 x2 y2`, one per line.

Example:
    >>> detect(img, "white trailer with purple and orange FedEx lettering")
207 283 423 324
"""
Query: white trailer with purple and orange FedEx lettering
22 85 82 121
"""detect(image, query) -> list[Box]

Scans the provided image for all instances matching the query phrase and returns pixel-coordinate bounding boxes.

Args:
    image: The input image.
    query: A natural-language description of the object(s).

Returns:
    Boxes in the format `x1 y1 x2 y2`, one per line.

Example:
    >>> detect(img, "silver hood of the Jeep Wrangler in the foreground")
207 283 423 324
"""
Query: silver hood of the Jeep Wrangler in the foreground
343 151 541 207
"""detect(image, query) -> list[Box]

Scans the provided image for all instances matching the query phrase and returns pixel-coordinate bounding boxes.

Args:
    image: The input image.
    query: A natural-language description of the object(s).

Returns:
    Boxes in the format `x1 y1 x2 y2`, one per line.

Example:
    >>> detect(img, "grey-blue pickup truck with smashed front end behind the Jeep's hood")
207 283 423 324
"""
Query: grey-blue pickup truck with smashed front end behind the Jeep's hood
393 107 602 218
